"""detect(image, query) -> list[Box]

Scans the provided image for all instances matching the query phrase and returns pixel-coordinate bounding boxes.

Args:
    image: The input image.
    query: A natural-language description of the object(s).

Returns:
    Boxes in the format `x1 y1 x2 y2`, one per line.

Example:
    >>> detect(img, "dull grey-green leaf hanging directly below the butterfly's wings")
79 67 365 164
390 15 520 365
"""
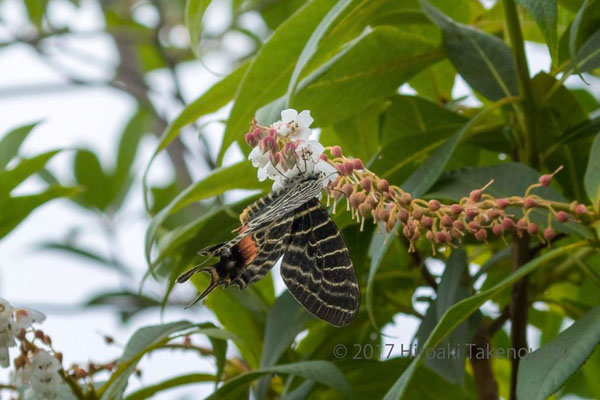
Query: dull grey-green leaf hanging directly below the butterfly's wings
257 290 316 399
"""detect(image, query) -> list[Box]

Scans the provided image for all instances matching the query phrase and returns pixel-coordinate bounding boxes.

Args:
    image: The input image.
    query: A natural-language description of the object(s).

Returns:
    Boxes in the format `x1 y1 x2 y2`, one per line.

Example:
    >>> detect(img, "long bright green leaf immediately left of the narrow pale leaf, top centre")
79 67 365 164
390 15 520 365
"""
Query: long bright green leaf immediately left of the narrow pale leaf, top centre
219 0 334 163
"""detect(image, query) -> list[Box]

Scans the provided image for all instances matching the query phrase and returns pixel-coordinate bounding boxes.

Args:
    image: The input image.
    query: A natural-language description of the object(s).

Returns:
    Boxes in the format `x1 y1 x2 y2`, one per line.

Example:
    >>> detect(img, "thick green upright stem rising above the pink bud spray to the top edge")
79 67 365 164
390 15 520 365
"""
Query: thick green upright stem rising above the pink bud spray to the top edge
502 0 538 167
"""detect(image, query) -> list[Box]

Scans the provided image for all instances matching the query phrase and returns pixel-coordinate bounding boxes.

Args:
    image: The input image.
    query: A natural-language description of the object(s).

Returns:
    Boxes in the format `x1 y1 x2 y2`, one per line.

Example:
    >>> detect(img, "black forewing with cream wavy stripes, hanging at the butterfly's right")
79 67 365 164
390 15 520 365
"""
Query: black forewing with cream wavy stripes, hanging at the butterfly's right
281 198 360 326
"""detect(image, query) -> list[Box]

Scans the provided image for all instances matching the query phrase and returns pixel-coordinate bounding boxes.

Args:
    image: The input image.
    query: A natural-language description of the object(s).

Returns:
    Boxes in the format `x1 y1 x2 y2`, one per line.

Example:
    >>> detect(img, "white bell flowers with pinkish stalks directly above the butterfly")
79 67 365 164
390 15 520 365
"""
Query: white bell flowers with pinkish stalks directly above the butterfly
246 109 338 191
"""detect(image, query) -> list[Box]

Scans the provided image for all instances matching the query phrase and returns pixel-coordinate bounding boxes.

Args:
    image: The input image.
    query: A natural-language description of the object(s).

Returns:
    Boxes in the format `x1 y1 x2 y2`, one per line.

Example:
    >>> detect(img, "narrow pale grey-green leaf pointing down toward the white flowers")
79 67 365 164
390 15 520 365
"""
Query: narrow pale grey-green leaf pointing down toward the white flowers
285 0 352 108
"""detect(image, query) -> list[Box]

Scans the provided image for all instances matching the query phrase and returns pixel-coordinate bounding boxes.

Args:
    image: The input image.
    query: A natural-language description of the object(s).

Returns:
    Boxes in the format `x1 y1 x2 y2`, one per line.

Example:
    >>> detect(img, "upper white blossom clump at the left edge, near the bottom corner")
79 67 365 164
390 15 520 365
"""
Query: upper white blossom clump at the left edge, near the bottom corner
0 297 46 368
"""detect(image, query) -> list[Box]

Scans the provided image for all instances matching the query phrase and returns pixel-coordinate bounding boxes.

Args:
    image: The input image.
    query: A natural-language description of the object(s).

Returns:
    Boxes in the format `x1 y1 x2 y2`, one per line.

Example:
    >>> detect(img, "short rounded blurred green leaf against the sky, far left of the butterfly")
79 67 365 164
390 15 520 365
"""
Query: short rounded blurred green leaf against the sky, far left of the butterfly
73 150 112 211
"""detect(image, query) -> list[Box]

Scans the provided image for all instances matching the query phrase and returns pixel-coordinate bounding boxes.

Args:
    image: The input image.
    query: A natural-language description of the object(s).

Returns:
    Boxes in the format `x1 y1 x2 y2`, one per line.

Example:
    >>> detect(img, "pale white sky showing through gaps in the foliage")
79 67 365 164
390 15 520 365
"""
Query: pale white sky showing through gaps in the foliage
0 0 600 399
